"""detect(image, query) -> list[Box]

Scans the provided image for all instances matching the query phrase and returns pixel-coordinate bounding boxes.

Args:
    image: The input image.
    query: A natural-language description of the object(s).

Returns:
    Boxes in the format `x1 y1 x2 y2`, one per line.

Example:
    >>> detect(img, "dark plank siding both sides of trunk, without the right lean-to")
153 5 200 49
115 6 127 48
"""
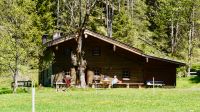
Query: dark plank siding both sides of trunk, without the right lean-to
47 37 144 85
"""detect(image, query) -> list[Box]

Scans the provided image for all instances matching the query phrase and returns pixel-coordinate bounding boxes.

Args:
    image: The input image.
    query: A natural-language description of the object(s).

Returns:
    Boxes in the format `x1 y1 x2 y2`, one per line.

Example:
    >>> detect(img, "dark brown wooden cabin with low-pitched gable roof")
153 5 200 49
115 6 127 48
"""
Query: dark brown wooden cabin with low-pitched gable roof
39 30 185 86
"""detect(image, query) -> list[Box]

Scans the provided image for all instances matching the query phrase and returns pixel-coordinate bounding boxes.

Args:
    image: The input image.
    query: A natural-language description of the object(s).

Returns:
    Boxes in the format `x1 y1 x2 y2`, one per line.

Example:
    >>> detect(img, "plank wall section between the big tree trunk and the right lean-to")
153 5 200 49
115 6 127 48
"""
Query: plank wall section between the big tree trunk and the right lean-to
83 37 143 82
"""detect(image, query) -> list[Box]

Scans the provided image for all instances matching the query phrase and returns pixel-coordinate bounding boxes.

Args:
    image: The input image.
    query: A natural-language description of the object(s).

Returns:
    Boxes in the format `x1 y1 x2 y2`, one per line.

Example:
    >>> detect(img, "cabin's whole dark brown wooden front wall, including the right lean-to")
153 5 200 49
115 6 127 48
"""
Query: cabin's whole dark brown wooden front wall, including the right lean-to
41 36 176 86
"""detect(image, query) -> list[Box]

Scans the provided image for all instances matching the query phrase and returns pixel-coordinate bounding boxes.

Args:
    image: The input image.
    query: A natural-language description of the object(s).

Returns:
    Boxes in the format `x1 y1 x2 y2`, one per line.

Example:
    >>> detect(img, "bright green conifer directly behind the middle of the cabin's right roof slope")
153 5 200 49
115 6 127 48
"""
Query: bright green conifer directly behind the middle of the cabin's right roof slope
113 0 153 53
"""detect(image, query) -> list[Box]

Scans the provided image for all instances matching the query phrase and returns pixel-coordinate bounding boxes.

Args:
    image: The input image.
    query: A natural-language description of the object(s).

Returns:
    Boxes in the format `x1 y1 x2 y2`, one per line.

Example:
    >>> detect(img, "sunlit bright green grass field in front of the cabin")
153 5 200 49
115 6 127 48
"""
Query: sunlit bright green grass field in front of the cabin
0 78 200 112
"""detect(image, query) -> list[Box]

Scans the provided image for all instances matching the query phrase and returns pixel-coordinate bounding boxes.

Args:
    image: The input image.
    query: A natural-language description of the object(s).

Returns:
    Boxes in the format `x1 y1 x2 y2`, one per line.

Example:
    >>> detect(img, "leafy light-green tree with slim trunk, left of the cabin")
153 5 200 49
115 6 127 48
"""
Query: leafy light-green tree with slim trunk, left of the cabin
0 0 41 92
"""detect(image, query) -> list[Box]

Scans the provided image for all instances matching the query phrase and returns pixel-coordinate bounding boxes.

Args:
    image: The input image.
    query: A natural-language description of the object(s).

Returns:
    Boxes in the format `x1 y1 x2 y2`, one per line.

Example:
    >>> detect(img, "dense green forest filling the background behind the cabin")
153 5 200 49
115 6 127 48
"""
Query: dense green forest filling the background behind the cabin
0 0 200 87
